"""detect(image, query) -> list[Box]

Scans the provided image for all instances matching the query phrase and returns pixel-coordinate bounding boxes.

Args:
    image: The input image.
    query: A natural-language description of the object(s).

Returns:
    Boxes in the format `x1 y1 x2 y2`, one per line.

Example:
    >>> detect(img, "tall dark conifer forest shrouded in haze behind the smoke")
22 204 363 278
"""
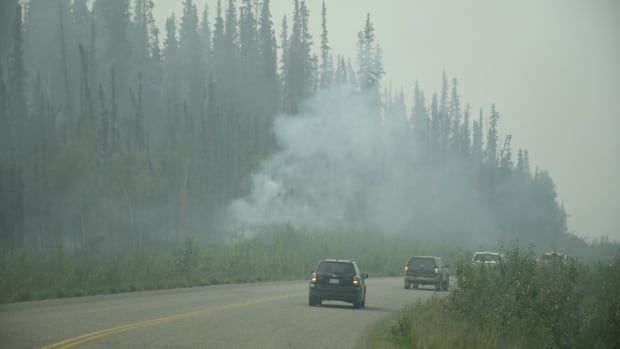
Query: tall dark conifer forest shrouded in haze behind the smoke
0 0 583 252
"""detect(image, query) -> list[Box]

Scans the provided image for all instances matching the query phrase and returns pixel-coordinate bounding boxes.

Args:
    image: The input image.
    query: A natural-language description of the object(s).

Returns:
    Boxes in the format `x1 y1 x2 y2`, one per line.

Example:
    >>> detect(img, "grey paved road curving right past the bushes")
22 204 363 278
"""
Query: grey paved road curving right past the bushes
0 277 446 348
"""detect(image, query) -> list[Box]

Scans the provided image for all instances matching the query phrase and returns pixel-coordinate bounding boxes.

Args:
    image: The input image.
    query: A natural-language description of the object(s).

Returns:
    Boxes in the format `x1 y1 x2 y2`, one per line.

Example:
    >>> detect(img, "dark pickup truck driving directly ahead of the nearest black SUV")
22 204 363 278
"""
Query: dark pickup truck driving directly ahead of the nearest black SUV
405 256 450 291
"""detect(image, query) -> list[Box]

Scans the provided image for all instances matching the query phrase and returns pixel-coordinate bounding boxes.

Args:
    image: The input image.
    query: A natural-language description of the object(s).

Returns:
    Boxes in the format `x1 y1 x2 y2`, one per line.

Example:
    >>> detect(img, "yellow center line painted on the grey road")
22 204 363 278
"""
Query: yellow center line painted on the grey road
41 295 292 349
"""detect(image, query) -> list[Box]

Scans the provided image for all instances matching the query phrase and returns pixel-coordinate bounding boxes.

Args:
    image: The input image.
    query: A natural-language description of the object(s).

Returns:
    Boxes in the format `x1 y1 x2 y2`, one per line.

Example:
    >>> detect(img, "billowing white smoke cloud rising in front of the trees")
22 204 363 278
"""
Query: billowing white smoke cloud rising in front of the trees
229 87 489 239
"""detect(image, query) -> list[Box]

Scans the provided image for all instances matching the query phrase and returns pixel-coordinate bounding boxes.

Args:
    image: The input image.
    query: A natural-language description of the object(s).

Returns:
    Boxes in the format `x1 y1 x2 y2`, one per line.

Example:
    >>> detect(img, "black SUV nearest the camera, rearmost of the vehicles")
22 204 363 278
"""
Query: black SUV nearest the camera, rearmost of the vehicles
308 259 368 309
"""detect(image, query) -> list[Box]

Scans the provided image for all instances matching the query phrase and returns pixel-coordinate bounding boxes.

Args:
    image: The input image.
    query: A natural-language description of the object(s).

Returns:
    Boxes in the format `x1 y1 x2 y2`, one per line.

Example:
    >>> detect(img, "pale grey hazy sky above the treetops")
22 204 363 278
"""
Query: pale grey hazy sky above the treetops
155 0 620 241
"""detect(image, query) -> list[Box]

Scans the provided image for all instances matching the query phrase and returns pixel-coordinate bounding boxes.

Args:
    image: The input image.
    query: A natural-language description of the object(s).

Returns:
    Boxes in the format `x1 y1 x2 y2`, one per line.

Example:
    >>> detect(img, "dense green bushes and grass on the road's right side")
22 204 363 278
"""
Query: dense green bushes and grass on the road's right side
369 248 620 348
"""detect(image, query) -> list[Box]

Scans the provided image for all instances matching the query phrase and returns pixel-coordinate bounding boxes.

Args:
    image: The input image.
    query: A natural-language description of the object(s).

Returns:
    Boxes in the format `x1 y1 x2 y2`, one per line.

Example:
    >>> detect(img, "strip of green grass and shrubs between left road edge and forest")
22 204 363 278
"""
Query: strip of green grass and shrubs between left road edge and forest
0 228 461 303
